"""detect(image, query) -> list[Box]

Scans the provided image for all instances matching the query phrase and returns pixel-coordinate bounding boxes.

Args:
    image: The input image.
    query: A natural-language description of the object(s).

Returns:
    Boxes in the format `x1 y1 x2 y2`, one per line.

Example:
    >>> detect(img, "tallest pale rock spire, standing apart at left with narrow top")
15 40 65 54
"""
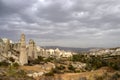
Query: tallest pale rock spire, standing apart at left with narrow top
19 34 28 65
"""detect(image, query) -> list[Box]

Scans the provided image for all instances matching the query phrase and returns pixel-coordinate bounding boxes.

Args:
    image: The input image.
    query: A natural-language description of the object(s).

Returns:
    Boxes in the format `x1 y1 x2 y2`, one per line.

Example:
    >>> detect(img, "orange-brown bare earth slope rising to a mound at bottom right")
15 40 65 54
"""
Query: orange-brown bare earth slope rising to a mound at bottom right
36 67 120 80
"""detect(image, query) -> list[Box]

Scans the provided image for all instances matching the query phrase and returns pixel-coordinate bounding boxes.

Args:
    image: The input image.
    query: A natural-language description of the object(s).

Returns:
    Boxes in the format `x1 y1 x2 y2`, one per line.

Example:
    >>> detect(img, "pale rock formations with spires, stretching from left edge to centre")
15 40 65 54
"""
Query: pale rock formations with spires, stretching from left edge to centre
0 34 72 65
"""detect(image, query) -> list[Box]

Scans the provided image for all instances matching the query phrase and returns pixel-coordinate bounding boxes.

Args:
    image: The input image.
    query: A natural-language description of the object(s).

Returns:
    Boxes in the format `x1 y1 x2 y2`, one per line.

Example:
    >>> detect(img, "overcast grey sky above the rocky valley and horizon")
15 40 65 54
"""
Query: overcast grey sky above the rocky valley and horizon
0 0 120 48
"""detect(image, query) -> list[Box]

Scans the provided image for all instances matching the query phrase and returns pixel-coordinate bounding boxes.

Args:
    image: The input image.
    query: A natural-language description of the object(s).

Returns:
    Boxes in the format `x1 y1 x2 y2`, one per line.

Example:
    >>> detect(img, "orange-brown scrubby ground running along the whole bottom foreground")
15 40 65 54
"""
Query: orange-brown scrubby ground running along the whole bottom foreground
0 65 120 80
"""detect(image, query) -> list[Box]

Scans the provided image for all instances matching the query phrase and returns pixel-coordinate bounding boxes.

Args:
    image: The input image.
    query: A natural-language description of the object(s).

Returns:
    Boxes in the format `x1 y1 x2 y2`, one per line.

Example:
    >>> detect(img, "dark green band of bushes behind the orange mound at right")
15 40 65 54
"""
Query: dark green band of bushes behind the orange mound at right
72 54 120 70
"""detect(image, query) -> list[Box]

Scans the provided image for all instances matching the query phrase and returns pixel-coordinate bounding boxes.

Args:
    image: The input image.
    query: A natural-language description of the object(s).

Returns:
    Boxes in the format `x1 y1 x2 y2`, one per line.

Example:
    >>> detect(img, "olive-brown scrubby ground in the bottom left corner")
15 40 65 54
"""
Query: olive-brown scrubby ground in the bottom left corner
0 66 35 80
